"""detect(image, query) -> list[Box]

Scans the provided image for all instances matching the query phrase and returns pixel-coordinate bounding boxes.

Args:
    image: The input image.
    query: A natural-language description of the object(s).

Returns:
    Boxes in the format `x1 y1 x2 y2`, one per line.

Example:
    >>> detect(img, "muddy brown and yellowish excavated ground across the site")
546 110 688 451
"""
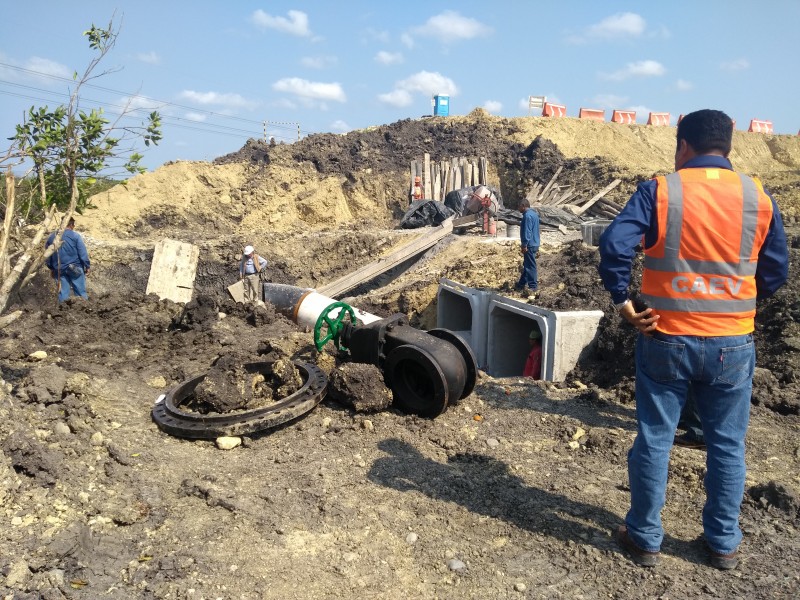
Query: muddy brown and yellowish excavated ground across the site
0 113 800 599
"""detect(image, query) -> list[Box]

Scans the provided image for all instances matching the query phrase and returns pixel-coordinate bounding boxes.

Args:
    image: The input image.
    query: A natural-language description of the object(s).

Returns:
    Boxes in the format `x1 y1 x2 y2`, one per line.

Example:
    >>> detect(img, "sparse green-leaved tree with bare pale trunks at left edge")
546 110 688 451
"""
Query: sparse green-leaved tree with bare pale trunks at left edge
0 19 161 313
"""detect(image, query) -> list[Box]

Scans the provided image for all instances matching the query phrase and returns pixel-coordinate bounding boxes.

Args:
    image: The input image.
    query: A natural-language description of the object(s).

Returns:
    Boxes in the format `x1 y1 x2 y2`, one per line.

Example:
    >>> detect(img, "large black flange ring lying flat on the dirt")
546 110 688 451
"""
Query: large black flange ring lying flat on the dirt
152 361 328 440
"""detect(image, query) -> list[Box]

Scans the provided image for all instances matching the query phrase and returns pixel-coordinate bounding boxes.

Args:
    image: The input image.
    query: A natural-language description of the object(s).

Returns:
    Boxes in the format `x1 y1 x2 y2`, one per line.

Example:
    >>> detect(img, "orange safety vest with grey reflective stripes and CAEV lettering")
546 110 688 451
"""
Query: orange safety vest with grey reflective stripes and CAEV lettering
642 168 772 337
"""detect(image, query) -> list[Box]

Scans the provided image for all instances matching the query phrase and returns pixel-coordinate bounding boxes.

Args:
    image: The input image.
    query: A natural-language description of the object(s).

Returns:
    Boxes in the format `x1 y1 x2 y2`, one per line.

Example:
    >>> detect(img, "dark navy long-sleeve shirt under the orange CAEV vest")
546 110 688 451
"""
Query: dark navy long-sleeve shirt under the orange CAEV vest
599 155 789 304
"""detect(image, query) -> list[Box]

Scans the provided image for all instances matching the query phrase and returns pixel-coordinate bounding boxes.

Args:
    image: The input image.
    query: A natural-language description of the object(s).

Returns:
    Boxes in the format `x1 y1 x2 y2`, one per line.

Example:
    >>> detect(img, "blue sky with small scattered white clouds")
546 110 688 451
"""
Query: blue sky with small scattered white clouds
0 0 800 169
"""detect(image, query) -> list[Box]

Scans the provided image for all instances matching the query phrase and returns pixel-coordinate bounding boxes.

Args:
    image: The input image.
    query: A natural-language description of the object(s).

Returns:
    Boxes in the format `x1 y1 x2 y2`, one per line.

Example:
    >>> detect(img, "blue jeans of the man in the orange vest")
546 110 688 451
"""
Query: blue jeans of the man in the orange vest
625 333 755 554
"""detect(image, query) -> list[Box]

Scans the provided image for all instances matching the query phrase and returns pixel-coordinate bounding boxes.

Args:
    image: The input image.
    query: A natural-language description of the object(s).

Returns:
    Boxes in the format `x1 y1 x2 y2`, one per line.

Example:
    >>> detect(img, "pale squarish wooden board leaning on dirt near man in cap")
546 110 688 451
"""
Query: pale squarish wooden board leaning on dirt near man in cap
145 238 200 303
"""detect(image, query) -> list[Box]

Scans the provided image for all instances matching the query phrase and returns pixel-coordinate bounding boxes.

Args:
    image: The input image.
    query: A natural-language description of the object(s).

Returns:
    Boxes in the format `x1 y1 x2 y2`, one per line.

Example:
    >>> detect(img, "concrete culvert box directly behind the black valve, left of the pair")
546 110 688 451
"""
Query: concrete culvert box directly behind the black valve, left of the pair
436 279 490 369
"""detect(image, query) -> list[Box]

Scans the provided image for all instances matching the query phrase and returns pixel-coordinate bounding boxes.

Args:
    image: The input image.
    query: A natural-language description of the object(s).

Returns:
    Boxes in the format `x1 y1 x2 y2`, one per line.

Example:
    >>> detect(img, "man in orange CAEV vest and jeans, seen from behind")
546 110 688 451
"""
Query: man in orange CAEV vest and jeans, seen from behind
600 110 789 569
